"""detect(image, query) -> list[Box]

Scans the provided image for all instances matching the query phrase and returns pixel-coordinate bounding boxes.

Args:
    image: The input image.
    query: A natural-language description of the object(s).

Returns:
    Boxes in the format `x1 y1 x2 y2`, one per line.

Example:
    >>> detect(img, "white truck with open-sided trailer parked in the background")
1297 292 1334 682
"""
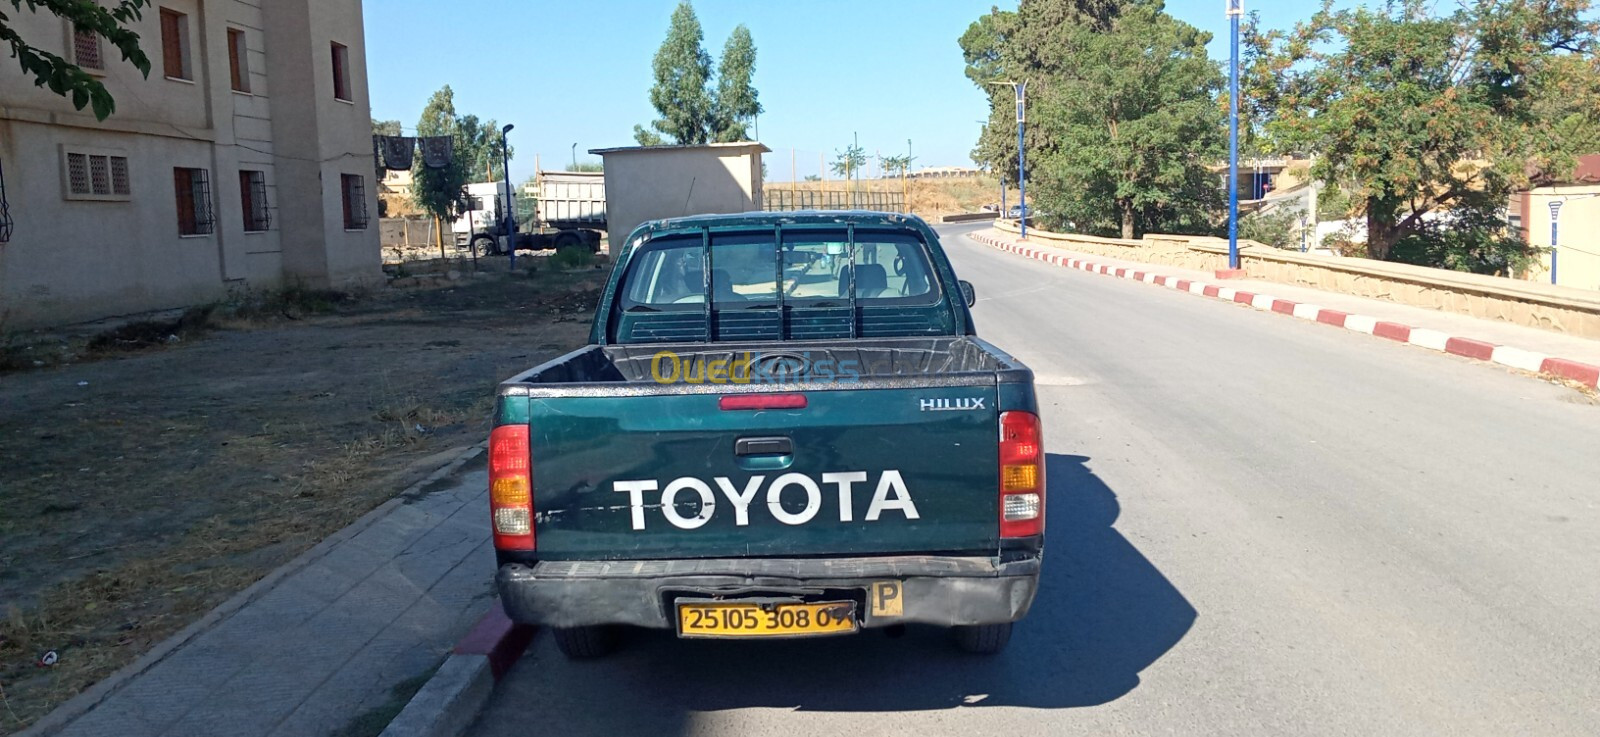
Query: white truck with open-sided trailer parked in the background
451 171 606 254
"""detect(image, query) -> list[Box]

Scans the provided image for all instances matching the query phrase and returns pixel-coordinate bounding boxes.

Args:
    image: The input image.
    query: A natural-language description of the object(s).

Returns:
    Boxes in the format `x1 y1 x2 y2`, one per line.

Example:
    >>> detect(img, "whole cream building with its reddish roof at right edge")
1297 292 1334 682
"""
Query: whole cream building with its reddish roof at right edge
1509 153 1600 289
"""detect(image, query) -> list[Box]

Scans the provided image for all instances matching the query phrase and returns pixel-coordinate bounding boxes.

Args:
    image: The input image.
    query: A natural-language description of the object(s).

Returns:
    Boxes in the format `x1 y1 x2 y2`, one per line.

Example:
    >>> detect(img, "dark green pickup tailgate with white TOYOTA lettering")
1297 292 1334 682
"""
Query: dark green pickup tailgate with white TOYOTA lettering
526 380 1000 560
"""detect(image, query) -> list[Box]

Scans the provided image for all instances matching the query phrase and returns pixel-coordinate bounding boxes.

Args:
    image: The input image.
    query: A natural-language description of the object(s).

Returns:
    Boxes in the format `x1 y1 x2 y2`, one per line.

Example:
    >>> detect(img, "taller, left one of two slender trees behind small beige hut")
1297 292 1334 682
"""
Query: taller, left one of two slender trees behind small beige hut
634 0 713 145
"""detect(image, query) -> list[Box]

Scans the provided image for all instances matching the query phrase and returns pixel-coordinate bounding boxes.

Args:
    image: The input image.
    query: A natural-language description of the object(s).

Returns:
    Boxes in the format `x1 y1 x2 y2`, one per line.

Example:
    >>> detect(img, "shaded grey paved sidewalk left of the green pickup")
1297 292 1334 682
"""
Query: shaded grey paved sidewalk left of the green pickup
24 451 494 737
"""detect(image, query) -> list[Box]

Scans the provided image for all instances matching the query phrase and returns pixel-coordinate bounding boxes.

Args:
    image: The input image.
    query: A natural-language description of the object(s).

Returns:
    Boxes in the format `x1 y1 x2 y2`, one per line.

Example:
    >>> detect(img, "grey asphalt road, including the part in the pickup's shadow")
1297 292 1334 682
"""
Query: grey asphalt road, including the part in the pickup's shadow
470 227 1600 737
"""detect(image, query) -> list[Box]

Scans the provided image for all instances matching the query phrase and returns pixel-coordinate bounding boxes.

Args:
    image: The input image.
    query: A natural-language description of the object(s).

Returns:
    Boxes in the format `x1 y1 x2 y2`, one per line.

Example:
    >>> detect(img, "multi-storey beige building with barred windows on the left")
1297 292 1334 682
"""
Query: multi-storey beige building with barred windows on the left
0 0 381 328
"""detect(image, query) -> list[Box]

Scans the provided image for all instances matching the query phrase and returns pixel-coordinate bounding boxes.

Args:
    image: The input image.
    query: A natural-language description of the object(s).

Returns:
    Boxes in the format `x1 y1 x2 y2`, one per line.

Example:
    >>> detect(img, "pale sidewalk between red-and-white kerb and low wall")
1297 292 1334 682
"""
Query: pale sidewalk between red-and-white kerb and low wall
971 230 1600 382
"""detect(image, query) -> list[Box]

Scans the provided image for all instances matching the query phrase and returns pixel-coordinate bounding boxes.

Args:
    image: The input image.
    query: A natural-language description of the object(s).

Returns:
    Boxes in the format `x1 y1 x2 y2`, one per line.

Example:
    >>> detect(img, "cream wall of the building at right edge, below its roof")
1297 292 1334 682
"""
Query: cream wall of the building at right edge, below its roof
1522 184 1600 289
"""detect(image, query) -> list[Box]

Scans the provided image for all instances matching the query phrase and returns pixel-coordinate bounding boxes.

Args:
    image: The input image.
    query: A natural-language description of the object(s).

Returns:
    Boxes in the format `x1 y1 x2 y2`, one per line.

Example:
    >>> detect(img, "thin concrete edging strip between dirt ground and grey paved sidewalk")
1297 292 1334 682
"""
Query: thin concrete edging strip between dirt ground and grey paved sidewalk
18 443 486 737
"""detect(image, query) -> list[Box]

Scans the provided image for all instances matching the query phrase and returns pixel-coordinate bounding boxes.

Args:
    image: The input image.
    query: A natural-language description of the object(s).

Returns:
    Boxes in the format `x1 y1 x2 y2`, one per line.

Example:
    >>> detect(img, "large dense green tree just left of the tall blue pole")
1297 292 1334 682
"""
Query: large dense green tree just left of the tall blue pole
960 0 1226 238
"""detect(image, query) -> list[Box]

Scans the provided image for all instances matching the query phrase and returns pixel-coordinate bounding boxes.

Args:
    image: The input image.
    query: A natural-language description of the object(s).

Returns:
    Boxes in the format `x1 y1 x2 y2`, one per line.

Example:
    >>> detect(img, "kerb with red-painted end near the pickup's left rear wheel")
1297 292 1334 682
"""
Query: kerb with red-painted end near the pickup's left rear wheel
379 600 533 737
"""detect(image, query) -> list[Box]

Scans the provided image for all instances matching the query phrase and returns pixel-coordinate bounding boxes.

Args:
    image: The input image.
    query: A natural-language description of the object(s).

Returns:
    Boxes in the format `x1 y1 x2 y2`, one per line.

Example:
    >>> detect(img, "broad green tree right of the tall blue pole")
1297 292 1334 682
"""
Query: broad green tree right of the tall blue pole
1250 0 1600 262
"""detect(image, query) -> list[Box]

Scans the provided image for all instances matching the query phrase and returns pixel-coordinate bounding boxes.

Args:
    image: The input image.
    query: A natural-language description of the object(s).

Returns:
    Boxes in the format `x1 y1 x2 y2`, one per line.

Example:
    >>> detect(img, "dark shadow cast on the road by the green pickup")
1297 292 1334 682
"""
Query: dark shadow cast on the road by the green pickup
512 454 1197 734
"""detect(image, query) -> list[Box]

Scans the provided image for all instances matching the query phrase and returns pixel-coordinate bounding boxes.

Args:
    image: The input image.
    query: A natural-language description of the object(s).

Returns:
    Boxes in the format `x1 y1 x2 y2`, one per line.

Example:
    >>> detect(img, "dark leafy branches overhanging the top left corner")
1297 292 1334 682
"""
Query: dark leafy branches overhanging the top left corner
0 0 150 120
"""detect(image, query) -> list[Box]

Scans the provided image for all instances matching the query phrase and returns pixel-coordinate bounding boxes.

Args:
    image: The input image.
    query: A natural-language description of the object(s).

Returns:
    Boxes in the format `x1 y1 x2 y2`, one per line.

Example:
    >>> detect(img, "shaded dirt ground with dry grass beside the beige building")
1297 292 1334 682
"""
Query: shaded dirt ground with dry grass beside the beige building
0 259 606 734
